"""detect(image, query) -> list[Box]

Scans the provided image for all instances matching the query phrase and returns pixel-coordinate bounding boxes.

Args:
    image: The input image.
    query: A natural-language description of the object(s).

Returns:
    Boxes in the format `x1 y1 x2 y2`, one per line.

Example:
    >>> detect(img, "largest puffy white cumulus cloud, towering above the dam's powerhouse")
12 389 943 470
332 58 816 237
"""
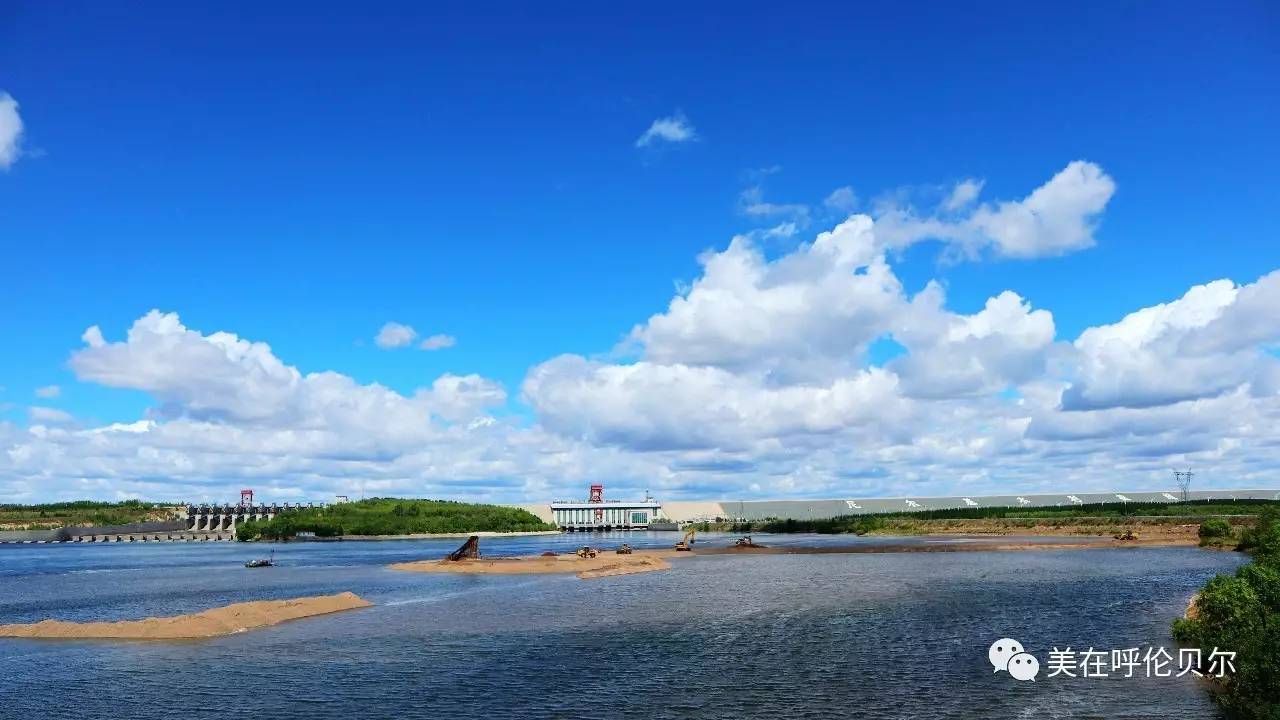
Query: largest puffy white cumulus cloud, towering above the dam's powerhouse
524 207 1055 451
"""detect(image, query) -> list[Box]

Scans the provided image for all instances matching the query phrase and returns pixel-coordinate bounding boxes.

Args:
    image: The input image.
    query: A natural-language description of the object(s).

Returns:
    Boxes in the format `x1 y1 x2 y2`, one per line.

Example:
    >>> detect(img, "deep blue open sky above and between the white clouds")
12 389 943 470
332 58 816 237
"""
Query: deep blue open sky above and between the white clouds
0 3 1280 498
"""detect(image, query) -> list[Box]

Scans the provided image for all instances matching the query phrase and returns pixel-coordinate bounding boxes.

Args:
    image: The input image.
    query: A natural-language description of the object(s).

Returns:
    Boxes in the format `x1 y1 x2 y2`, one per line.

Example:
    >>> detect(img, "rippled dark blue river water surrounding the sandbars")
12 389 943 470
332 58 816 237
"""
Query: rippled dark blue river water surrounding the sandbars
0 533 1244 720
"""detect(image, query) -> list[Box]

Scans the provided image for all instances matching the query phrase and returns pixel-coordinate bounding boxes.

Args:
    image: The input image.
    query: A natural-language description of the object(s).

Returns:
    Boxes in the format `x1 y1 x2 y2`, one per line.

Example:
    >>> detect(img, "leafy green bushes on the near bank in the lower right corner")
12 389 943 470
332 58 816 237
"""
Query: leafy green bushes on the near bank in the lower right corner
1174 509 1280 720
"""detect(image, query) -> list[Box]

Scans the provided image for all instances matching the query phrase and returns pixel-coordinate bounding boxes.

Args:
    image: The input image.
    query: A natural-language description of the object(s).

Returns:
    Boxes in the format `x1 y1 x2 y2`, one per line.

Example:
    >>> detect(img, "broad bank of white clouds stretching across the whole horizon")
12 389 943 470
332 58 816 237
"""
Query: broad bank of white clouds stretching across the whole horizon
0 160 1280 501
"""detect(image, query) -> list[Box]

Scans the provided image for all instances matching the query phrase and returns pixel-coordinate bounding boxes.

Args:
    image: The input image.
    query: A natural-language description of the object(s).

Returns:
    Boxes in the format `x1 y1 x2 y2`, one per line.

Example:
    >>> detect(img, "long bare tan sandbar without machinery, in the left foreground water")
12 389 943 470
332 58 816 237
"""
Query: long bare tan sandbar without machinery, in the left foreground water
0 592 372 641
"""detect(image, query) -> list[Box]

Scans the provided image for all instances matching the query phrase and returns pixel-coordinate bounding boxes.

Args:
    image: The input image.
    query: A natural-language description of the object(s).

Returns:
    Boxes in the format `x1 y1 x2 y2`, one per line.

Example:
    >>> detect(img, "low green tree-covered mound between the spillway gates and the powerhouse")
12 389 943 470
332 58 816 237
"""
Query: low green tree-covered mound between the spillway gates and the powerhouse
236 497 556 541
